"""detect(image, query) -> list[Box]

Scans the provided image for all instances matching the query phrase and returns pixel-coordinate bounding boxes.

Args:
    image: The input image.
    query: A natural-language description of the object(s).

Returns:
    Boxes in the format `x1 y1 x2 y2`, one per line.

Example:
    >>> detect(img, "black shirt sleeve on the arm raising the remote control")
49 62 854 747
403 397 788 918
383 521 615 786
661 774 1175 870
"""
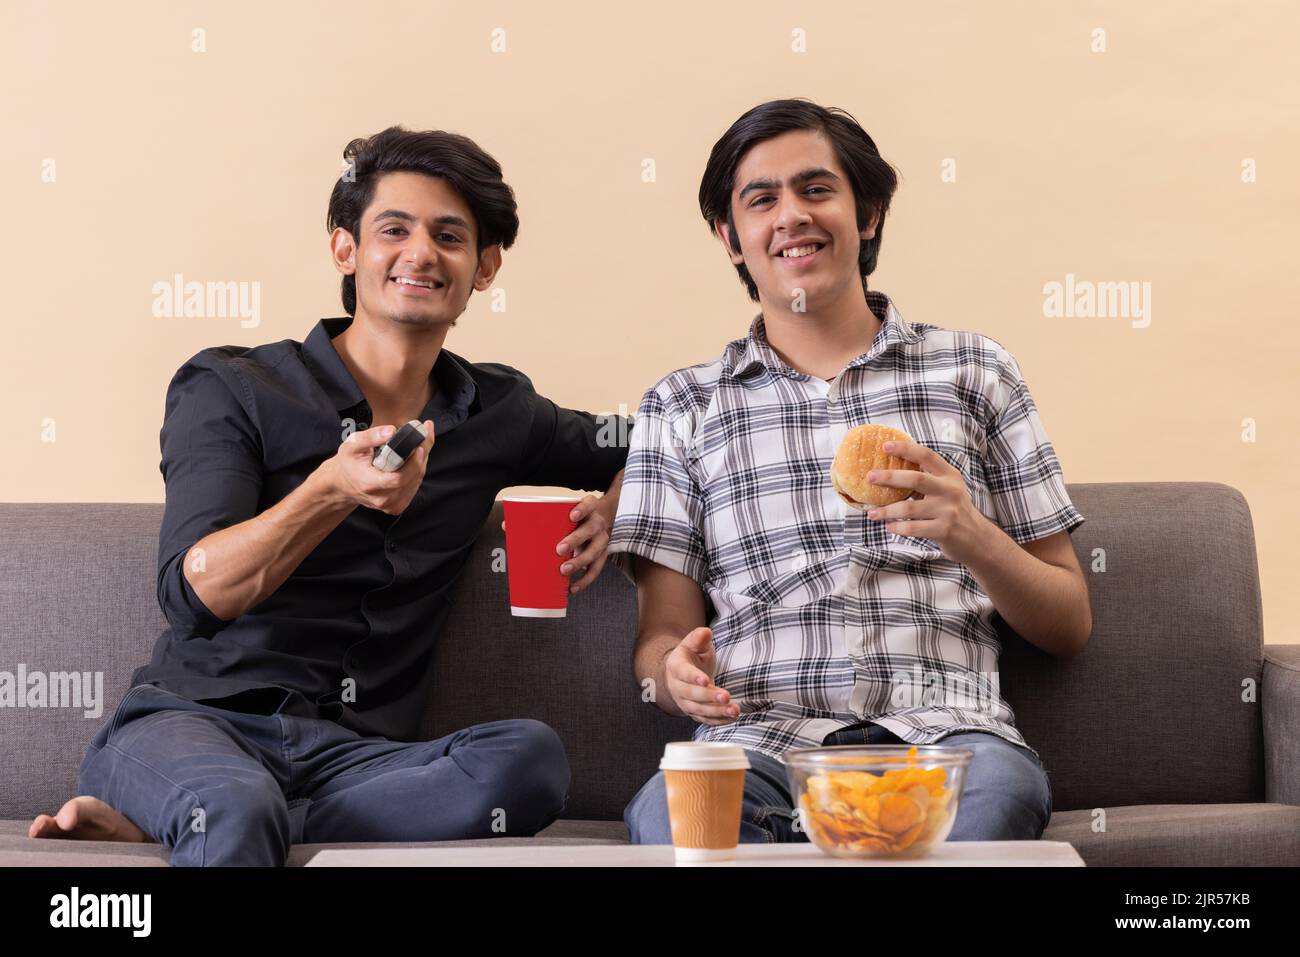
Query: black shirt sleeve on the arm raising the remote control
157 354 263 637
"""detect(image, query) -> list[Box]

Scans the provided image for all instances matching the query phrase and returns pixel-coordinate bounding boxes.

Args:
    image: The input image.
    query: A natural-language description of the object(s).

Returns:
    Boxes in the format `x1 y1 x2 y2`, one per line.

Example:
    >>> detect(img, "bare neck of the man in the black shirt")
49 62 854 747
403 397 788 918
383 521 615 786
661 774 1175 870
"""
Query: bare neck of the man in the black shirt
333 306 447 413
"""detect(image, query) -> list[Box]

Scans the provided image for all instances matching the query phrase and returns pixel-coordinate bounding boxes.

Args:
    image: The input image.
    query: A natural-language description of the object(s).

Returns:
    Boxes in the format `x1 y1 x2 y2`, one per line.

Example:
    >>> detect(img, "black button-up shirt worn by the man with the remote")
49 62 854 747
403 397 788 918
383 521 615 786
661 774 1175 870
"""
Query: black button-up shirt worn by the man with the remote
131 317 631 741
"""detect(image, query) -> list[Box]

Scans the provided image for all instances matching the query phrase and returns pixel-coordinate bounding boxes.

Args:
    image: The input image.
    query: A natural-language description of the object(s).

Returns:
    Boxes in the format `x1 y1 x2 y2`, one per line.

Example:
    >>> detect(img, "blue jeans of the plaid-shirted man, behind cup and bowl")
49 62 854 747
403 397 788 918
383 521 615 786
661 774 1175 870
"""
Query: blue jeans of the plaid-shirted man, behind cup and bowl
623 724 1052 844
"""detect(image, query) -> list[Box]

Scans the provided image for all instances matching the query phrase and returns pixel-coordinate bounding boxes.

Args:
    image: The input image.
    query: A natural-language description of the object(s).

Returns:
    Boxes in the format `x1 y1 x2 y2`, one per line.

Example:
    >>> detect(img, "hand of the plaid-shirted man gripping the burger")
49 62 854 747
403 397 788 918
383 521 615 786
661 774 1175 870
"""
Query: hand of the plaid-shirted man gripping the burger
867 442 989 563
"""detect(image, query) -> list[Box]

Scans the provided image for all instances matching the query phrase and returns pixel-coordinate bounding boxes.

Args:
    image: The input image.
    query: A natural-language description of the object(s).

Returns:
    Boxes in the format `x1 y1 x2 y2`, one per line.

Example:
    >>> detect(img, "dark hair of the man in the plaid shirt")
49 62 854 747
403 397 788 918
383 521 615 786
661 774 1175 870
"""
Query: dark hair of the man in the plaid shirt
699 98 898 302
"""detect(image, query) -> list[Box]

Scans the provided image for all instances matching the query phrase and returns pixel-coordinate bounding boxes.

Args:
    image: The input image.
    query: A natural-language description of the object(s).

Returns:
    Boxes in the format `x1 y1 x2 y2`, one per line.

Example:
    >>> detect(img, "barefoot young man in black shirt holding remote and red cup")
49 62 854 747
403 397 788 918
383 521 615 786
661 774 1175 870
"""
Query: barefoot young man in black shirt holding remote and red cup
30 127 627 865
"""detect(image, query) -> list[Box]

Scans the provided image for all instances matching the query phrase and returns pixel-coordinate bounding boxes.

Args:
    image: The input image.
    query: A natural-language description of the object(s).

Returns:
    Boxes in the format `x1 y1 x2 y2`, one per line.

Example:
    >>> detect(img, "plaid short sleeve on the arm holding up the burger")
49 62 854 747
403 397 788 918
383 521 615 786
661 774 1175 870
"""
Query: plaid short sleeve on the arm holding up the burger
983 350 1084 545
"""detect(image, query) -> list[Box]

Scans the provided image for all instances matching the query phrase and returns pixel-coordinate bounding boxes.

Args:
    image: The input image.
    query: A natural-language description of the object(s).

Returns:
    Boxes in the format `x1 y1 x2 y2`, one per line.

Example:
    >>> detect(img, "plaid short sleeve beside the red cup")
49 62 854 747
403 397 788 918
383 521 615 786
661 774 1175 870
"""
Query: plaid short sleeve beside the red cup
608 386 709 588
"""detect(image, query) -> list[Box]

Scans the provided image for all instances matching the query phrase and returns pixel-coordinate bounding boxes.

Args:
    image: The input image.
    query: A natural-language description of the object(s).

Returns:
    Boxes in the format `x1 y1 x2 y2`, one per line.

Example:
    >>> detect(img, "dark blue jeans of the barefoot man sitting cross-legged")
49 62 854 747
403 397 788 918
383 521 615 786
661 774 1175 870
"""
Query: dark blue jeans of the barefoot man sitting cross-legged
78 685 569 866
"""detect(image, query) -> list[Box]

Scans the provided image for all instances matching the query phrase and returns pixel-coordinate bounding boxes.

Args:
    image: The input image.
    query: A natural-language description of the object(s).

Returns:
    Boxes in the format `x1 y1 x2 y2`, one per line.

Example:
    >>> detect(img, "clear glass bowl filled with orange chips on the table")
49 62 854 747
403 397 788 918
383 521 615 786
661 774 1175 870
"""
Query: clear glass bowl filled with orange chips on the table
781 744 974 858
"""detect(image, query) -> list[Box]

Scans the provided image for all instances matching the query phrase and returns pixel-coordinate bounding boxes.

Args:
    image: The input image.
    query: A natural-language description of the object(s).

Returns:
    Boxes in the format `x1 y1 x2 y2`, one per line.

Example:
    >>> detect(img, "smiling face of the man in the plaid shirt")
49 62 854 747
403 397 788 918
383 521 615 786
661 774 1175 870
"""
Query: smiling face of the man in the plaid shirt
714 130 879 315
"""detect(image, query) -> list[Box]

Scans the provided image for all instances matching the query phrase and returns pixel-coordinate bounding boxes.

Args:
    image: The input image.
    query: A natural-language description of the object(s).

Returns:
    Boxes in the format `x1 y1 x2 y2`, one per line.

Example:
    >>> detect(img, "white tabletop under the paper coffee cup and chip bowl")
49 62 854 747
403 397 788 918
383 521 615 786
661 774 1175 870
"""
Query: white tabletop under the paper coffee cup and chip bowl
307 841 1084 867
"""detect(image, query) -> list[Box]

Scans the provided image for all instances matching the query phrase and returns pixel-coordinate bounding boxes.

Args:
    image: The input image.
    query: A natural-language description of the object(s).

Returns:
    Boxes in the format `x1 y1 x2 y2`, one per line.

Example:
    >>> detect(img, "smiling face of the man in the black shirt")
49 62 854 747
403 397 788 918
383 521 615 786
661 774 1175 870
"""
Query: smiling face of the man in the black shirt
330 173 501 328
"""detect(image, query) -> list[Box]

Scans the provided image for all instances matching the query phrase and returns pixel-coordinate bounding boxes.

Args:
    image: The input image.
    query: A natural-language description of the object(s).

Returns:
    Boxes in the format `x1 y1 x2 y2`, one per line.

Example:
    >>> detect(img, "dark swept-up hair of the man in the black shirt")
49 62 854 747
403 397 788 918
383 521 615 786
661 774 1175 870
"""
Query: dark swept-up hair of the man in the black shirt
325 126 519 316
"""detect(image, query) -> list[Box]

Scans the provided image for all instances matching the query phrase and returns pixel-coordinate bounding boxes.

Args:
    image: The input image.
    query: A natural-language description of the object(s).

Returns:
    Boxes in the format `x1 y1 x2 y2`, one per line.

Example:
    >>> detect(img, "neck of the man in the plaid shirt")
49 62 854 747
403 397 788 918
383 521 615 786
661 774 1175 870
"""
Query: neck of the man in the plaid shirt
762 282 881 380
